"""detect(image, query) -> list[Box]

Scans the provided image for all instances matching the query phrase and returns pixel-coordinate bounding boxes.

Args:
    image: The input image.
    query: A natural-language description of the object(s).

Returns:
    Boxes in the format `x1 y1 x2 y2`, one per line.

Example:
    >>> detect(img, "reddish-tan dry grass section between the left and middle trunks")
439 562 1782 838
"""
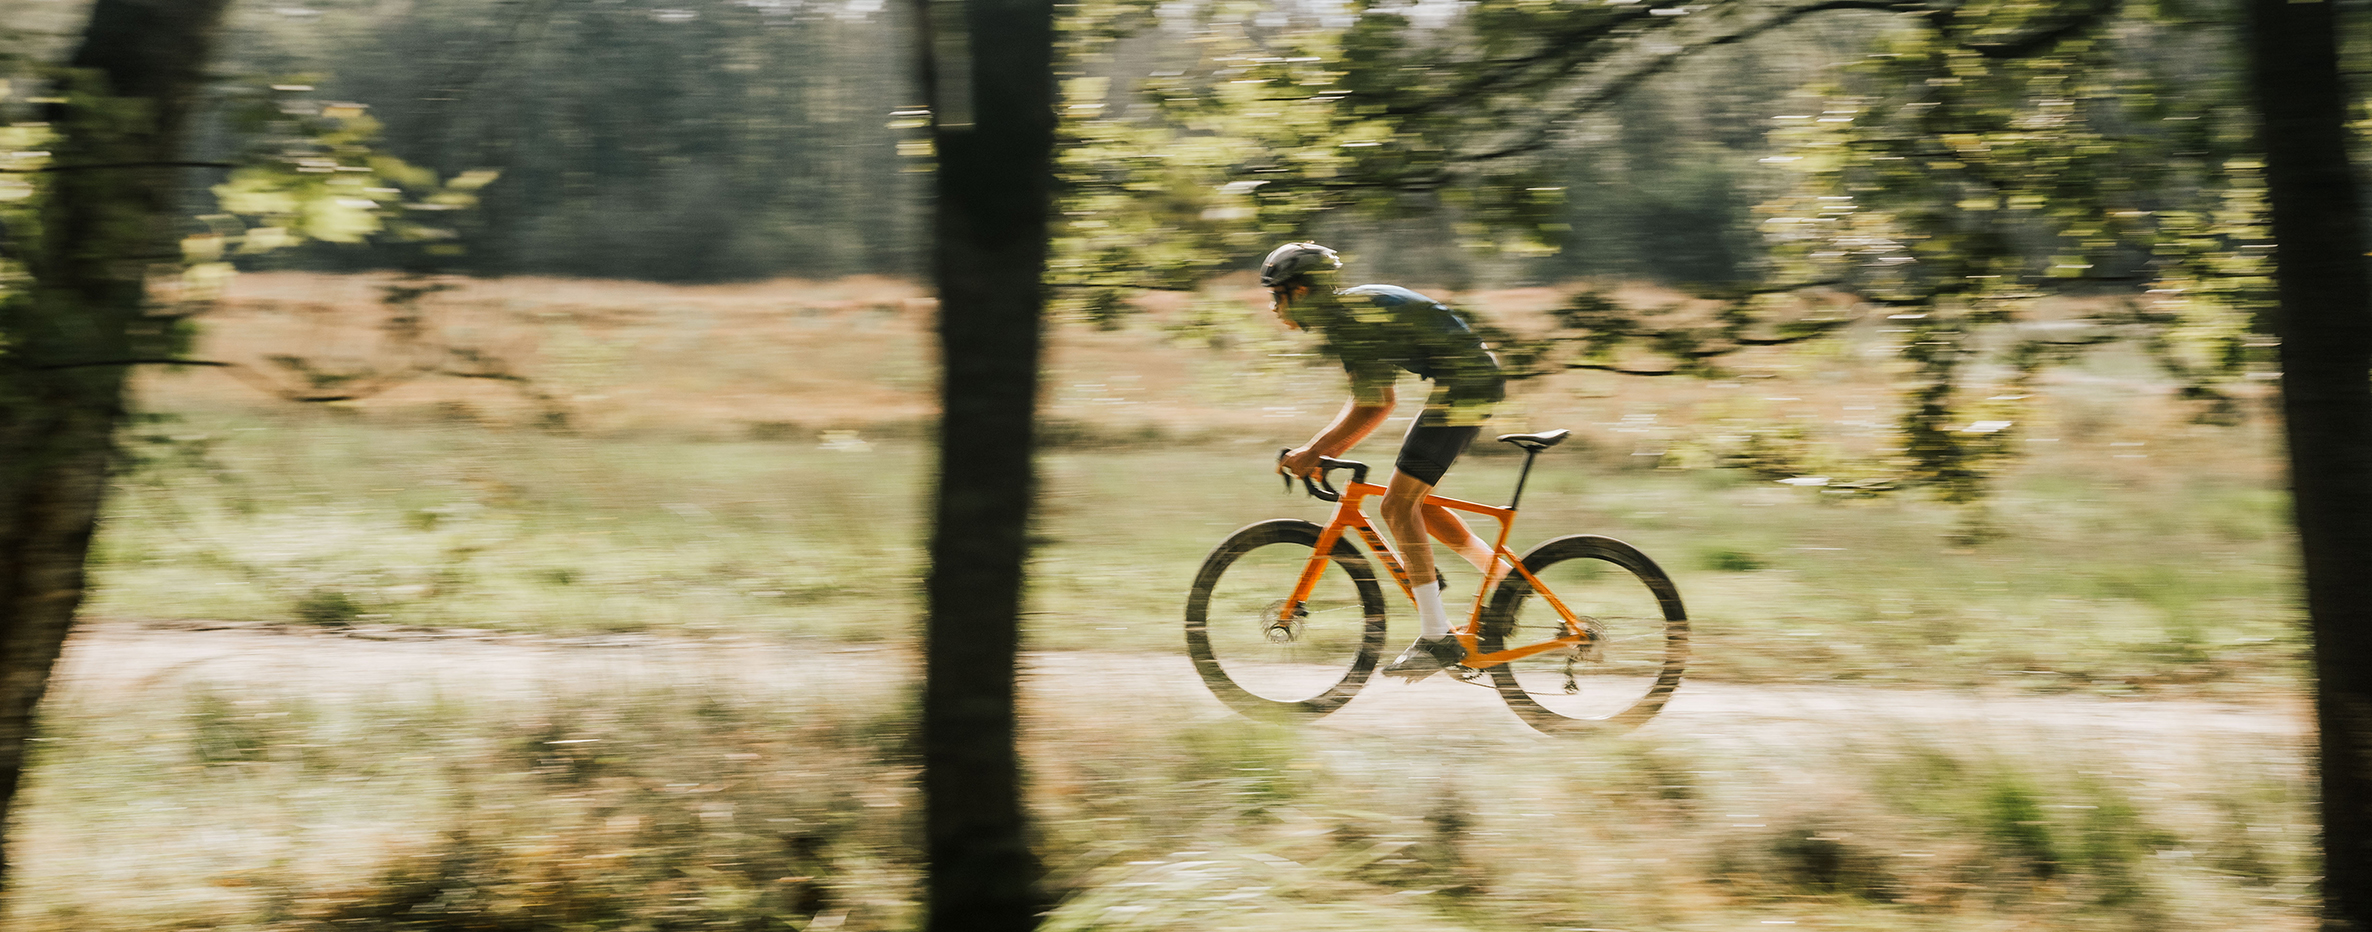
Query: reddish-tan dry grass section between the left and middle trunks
171 273 932 434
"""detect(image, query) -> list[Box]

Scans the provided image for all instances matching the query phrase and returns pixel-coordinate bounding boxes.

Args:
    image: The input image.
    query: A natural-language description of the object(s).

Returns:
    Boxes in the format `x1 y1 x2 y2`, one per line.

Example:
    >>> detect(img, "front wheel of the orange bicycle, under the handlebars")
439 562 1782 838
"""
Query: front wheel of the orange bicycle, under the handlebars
1186 519 1383 721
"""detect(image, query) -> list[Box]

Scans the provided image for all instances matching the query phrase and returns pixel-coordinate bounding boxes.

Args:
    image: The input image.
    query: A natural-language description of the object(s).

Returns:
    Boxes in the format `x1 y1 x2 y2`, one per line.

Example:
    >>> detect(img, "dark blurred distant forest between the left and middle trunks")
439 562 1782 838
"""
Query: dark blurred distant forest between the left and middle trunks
223 0 927 282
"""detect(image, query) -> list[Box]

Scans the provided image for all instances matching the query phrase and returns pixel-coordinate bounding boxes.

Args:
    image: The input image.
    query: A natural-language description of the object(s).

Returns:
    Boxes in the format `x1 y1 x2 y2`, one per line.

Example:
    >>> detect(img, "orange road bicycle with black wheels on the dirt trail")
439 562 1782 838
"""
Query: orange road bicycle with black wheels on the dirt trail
1186 429 1689 730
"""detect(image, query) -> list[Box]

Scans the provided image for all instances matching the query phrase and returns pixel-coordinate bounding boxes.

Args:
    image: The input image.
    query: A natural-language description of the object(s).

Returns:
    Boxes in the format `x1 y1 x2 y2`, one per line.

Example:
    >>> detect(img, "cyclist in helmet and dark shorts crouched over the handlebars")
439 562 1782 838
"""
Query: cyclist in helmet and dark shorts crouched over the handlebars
1260 242 1506 683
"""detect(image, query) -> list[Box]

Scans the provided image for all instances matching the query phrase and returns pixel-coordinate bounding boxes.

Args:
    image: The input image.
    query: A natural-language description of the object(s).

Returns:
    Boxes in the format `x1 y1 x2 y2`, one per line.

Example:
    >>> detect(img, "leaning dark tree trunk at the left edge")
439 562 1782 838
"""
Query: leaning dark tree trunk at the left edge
0 0 228 882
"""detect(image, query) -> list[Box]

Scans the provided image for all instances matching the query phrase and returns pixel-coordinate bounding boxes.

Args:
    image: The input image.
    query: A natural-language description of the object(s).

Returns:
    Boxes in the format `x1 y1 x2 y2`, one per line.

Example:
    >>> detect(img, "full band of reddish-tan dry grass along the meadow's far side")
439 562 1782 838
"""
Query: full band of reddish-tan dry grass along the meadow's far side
167 273 2268 470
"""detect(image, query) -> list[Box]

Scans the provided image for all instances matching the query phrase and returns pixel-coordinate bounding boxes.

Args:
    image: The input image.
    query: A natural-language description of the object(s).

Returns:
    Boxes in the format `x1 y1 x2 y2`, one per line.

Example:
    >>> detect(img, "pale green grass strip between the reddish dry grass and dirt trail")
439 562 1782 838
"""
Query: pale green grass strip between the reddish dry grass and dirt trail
93 422 2298 690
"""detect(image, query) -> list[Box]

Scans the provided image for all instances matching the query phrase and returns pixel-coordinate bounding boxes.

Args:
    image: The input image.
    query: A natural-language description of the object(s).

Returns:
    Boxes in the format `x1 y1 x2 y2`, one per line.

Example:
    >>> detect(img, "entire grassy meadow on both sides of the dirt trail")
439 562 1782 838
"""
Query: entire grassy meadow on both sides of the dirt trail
12 266 2315 930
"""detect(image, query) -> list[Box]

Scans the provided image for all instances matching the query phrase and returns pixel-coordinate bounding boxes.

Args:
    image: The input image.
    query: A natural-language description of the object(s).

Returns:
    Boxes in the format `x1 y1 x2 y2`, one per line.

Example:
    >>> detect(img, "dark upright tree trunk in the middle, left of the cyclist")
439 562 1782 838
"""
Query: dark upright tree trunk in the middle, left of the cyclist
916 0 1053 932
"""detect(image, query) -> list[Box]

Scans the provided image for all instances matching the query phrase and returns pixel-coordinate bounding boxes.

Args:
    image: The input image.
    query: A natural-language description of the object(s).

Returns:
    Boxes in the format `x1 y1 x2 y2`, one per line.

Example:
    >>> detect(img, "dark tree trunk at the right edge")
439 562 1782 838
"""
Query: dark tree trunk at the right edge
2249 0 2372 930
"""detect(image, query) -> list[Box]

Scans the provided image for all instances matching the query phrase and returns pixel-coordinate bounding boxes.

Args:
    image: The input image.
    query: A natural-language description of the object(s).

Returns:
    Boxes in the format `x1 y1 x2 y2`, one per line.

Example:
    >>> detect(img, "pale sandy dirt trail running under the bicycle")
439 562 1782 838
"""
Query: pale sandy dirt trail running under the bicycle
52 621 2310 747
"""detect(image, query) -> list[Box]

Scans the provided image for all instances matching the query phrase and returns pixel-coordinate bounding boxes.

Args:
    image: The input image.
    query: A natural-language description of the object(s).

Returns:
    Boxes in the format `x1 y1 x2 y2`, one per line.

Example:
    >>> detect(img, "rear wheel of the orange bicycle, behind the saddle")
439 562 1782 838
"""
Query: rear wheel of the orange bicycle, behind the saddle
1478 534 1689 730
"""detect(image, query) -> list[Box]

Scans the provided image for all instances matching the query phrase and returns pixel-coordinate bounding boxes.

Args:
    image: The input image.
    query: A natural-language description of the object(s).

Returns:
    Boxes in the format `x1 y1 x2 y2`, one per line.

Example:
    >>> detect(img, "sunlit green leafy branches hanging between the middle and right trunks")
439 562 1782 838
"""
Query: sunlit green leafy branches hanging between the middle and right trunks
1053 0 2305 519
